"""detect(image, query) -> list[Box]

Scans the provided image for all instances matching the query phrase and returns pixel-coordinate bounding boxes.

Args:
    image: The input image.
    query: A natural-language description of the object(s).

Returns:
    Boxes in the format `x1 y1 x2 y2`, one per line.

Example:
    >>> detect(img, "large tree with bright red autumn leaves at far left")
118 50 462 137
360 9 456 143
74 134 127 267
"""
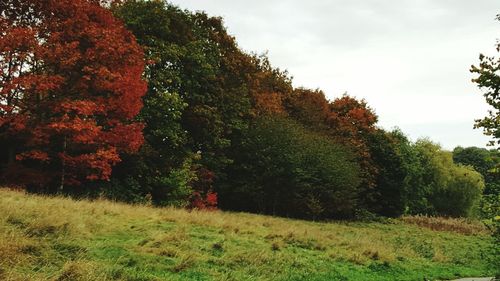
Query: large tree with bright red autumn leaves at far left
0 0 146 189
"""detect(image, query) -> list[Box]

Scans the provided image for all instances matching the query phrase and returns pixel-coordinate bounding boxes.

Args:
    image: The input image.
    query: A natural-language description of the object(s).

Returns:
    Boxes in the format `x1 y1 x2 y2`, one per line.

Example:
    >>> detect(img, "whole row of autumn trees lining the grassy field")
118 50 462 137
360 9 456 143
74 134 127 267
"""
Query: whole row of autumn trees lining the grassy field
0 0 499 219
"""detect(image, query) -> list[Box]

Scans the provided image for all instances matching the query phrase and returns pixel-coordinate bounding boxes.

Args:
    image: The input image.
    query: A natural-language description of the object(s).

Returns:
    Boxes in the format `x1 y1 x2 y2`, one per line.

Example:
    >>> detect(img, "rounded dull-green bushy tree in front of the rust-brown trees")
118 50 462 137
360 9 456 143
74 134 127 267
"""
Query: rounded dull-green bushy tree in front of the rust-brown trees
220 116 360 219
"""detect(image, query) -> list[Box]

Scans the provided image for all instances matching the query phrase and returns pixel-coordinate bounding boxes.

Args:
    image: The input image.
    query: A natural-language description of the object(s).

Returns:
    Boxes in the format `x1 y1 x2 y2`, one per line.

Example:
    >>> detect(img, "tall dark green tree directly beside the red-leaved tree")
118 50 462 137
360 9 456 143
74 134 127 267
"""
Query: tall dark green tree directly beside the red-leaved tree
105 0 260 204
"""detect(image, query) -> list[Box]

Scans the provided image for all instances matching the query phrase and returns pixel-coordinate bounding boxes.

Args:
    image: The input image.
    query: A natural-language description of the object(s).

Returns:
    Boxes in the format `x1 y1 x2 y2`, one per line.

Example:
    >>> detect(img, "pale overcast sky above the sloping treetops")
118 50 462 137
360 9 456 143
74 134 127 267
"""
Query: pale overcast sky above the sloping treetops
170 0 500 149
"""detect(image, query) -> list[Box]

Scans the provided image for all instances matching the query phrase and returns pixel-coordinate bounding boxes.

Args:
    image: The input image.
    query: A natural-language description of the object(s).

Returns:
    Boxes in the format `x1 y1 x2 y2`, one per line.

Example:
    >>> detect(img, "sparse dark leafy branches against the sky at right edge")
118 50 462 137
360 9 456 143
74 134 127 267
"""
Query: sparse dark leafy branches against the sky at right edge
470 15 500 145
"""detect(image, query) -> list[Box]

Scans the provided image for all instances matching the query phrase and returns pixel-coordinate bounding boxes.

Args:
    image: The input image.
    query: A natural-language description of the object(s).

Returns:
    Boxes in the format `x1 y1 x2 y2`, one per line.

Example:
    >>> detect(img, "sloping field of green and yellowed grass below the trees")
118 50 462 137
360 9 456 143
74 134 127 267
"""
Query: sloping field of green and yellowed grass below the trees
0 189 493 281
